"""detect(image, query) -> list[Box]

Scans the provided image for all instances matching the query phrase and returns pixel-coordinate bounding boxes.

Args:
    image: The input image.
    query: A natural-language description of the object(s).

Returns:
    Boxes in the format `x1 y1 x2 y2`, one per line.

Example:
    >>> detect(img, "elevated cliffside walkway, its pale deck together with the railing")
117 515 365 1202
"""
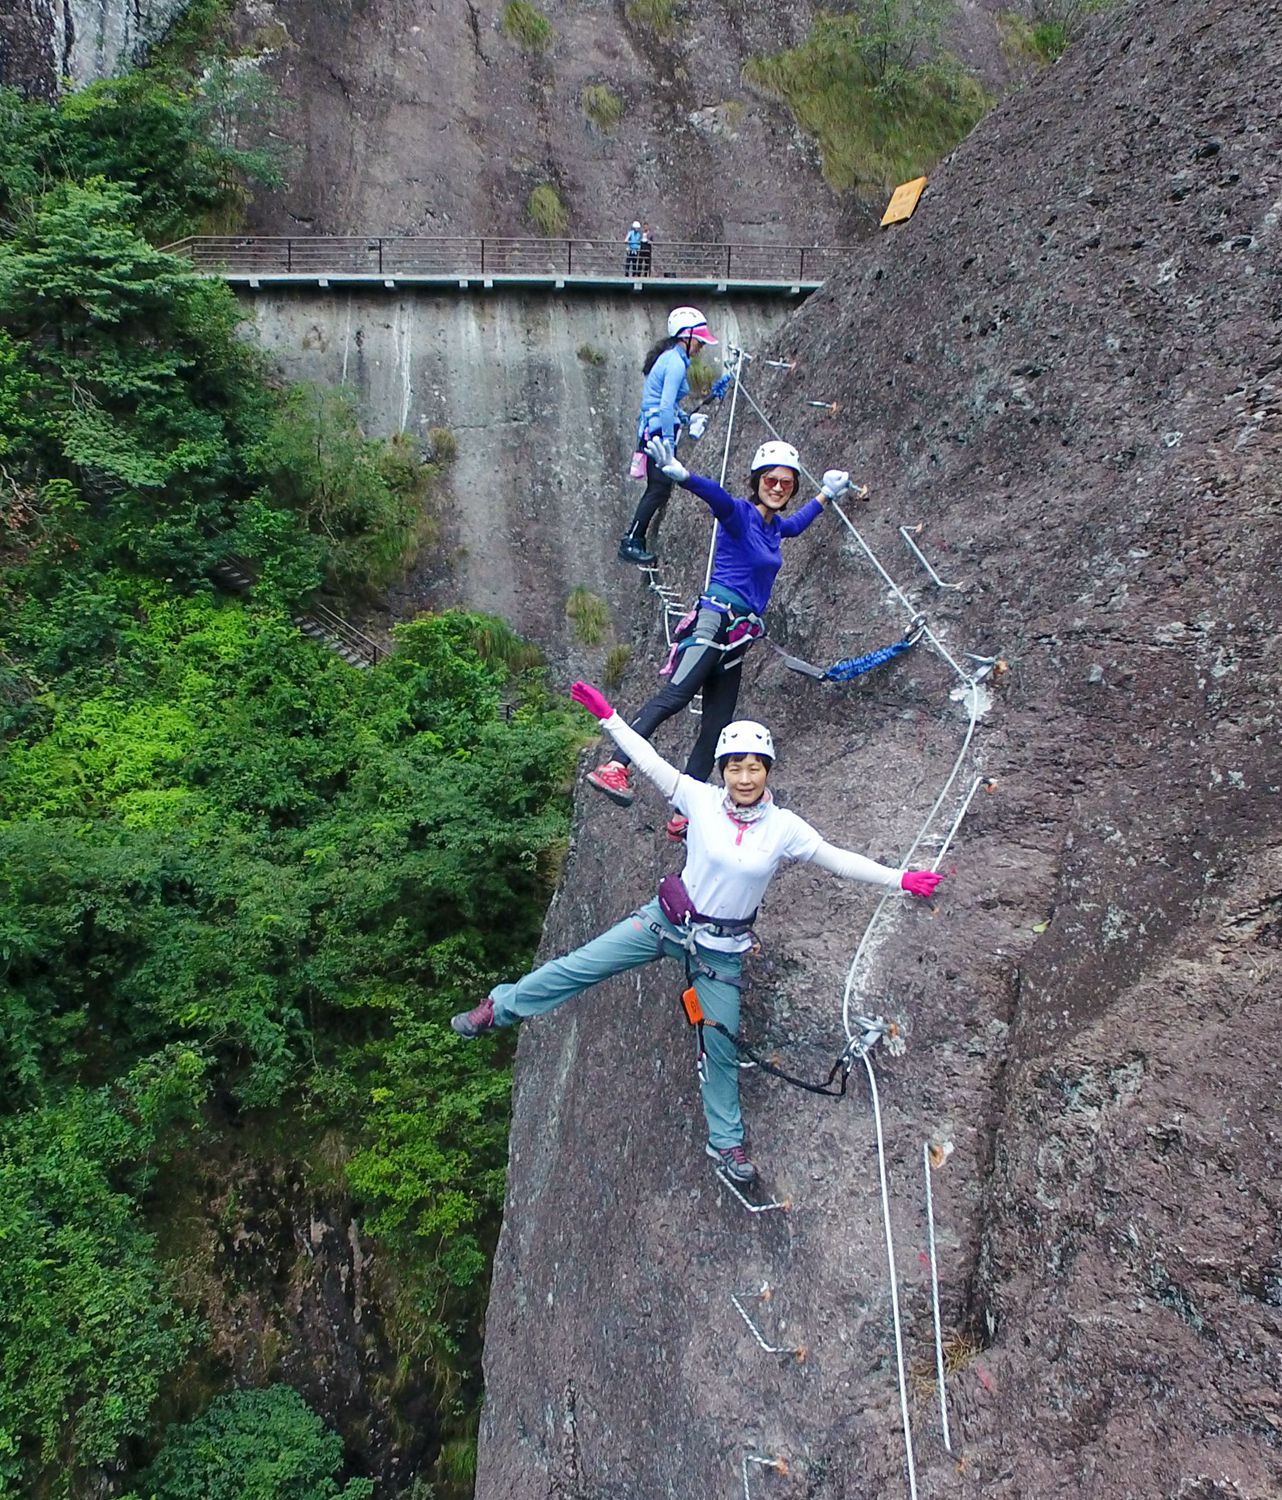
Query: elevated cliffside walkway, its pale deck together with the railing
168 234 858 297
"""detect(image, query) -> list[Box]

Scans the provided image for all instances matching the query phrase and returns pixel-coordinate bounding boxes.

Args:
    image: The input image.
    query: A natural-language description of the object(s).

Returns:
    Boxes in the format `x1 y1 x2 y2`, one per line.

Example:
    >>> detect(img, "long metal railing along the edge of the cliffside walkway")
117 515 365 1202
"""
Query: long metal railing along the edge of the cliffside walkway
166 234 856 284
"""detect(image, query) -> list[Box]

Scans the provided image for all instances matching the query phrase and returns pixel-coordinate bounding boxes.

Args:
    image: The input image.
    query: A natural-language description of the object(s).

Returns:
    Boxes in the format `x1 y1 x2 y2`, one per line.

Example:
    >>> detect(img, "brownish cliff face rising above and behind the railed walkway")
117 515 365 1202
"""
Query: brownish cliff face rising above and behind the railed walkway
224 0 1009 245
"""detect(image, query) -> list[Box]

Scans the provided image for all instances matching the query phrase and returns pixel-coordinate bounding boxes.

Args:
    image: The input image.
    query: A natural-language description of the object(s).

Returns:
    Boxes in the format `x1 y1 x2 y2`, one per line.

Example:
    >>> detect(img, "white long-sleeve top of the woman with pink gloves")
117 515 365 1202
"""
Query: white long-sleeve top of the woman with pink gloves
603 714 904 953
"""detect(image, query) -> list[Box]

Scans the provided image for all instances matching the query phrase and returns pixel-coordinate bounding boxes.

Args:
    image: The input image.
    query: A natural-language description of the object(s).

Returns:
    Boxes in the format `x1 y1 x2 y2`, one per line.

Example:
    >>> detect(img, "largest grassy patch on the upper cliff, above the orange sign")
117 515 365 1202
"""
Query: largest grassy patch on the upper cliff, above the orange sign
744 15 993 192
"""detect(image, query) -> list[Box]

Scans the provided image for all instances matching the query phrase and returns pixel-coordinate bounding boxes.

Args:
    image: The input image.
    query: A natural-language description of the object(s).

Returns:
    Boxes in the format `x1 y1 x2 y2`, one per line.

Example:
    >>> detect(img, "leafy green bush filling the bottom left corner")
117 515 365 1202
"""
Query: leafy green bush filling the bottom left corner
0 1049 204 1497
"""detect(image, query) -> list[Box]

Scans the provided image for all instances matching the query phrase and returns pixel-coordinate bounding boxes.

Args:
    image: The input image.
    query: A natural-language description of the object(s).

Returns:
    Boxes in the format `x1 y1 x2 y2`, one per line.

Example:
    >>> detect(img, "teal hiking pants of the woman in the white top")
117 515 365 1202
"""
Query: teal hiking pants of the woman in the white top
492 900 744 1151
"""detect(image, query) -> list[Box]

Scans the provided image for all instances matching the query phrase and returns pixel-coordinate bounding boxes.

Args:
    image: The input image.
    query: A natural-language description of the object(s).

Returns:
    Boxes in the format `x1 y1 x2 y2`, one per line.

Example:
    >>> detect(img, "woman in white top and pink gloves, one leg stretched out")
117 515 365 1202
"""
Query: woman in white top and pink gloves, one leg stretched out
450 696 940 1184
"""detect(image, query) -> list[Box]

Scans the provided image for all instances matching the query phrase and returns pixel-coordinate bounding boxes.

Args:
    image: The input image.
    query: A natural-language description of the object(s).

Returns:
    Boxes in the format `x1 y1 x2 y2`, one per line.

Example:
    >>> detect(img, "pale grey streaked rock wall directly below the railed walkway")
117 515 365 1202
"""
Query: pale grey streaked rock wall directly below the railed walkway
244 290 787 669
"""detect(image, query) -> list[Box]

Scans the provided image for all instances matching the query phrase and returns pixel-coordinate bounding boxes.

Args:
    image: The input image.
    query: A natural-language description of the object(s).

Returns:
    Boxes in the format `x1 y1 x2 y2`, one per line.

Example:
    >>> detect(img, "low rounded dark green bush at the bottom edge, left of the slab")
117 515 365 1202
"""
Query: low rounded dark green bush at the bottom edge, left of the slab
126 1386 373 1500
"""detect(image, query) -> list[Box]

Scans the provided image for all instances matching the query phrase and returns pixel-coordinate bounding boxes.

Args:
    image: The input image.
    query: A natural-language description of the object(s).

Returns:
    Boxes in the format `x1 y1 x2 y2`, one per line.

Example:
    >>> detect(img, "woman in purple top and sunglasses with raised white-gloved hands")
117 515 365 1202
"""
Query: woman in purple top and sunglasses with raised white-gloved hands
588 438 850 839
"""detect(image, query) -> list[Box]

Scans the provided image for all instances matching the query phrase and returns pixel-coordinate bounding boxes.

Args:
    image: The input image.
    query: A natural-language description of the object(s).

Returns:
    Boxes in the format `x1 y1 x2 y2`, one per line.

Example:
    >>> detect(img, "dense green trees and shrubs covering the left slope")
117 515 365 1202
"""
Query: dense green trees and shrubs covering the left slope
0 23 579 1500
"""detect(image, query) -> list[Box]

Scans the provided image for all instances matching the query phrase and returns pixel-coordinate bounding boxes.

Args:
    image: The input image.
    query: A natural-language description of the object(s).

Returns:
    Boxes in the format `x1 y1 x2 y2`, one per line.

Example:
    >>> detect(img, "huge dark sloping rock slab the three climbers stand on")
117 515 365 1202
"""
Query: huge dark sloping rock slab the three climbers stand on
477 0 1282 1500
